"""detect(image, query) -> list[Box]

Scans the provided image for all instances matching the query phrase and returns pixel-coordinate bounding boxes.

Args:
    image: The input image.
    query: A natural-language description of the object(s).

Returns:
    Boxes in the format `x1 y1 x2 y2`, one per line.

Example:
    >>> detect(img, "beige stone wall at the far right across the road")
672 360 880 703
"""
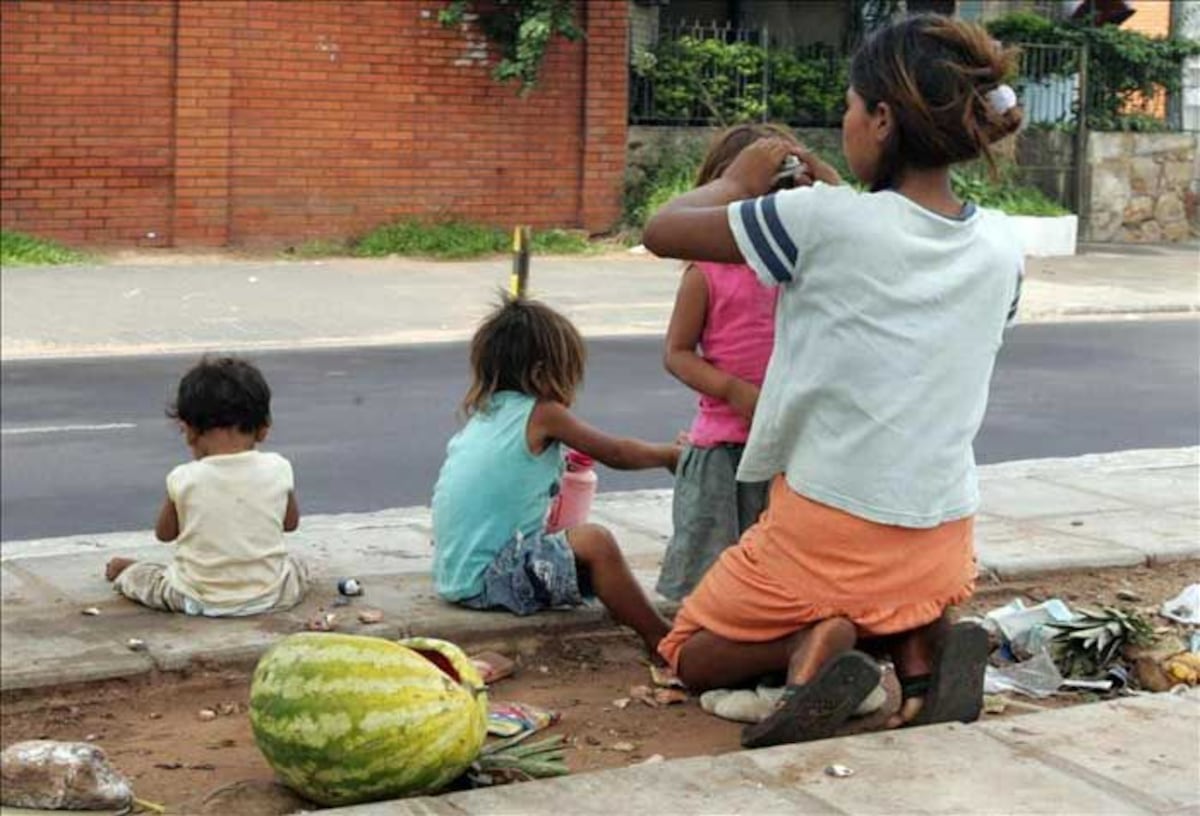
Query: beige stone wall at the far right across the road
1084 133 1200 244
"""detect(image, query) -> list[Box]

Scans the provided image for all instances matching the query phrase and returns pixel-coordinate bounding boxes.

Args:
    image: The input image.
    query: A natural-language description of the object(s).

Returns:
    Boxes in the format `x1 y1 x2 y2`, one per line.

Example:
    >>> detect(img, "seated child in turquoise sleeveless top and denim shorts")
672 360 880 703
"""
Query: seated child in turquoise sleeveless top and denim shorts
433 299 679 654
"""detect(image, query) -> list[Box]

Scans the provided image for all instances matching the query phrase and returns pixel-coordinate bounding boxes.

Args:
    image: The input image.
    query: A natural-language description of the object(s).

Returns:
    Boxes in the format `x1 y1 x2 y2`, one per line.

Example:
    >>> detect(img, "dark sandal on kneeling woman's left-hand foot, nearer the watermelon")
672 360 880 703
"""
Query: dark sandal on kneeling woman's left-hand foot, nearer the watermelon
742 650 880 748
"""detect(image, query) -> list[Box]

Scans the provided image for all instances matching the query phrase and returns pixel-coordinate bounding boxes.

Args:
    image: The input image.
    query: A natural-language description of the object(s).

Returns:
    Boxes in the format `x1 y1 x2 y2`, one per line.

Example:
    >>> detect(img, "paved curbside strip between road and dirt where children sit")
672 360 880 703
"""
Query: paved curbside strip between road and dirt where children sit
0 448 1200 692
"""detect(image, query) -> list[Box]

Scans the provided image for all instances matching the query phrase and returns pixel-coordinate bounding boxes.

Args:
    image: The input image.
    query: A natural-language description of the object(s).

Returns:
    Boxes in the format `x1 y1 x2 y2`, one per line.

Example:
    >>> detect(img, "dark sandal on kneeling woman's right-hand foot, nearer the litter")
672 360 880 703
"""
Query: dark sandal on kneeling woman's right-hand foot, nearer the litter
900 623 988 726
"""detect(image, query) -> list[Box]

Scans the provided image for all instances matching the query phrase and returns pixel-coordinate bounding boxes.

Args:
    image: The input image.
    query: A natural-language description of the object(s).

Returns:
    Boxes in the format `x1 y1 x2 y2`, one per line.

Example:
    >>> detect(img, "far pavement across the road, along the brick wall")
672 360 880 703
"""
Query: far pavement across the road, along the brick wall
0 244 1200 361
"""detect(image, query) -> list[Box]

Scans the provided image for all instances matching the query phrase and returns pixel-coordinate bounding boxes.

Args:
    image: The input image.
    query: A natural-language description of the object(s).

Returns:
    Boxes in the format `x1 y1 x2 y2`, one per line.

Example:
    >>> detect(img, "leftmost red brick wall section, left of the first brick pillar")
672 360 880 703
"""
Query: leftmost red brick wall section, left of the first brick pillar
0 0 173 245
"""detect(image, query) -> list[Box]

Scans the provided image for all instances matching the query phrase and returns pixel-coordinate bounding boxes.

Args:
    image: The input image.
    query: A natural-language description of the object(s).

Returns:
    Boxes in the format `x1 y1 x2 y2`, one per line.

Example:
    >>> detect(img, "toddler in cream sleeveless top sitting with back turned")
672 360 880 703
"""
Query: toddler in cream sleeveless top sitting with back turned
104 358 308 617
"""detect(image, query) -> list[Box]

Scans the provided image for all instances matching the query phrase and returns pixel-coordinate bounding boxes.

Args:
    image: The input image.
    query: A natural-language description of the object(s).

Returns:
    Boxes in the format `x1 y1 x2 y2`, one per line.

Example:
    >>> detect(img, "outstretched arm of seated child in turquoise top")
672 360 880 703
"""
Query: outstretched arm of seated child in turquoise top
526 402 679 473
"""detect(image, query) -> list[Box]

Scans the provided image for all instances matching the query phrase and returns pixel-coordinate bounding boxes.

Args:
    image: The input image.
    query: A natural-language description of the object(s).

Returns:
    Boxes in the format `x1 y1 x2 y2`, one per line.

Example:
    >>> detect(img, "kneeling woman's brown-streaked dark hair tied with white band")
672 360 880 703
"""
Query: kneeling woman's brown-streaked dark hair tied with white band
850 14 1021 191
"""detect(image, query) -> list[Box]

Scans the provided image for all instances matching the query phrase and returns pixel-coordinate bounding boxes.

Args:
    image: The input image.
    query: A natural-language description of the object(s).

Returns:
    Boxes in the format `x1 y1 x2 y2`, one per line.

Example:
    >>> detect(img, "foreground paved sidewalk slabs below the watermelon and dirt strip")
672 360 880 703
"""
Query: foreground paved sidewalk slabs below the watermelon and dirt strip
323 689 1200 816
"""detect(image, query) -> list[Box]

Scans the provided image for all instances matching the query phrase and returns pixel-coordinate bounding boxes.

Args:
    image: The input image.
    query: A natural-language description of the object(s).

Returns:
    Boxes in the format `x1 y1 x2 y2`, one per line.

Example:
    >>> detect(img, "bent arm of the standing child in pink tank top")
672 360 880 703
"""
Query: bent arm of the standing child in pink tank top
662 266 758 419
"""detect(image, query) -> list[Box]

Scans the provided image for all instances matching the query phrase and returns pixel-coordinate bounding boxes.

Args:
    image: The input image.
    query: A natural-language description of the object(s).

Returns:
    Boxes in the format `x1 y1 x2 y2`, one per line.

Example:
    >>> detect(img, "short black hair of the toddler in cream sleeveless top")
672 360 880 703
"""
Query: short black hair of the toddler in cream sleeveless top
167 356 271 433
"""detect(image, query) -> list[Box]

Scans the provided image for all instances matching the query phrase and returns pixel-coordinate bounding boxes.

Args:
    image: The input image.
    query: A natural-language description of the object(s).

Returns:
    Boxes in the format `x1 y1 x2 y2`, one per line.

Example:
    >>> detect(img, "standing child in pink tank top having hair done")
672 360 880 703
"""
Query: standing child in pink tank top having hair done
658 125 792 600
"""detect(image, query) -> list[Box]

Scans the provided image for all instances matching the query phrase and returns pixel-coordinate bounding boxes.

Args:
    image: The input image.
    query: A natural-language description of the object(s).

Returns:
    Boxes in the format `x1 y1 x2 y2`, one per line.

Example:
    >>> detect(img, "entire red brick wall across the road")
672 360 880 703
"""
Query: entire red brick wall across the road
0 0 628 246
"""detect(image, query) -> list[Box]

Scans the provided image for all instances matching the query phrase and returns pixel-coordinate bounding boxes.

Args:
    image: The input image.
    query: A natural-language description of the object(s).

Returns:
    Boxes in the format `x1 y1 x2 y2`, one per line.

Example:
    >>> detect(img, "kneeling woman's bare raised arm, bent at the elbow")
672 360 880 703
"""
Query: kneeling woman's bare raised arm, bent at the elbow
642 139 840 263
